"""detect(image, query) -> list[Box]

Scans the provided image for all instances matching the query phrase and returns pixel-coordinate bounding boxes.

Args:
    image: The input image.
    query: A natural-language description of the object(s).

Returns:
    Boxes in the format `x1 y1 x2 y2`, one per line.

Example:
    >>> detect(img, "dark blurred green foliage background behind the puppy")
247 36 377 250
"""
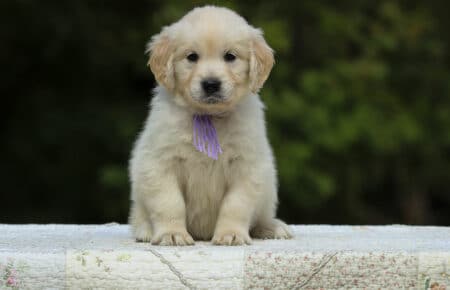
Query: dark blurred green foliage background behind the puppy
0 0 450 225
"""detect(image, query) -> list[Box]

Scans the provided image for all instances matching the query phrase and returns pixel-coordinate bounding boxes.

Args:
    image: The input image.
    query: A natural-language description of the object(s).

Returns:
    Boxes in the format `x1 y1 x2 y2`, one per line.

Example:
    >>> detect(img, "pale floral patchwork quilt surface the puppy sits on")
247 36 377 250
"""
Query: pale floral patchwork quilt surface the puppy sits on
0 224 450 289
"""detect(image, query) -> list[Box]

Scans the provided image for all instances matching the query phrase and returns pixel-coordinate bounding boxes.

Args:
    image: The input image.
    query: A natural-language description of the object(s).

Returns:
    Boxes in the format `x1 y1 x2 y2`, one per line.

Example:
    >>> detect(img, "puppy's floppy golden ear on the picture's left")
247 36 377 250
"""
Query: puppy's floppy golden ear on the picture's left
146 30 175 90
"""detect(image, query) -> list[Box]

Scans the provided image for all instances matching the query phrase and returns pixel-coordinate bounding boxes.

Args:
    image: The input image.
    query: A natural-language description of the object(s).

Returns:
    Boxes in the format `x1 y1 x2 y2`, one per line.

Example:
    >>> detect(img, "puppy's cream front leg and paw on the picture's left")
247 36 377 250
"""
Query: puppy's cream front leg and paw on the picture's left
133 173 194 246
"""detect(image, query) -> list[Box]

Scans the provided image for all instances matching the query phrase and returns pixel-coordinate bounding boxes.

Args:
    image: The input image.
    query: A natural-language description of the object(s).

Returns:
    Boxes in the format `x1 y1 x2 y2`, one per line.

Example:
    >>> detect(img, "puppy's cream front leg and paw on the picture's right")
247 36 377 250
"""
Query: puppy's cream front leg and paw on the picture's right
212 184 256 245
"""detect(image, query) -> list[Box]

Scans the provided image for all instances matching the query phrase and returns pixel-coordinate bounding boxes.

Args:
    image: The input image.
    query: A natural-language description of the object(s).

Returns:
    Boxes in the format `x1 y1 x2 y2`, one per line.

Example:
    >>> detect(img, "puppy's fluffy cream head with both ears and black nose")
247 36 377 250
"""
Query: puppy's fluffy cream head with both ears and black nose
148 6 274 112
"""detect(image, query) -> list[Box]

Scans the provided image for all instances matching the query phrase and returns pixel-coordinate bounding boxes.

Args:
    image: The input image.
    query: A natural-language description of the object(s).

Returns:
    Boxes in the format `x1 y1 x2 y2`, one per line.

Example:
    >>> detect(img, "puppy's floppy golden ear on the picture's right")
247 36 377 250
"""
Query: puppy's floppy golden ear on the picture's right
249 29 275 93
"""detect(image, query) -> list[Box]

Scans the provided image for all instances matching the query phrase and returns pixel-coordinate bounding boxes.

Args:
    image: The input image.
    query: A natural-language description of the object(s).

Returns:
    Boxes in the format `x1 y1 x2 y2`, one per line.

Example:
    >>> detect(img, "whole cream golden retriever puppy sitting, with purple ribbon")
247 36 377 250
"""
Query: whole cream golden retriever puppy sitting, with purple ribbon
130 6 291 245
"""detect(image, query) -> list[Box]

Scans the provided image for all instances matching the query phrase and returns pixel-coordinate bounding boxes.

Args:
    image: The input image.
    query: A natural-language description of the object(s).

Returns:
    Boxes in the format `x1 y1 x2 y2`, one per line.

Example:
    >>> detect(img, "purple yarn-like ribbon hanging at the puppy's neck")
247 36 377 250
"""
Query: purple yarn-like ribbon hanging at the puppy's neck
192 115 222 160
